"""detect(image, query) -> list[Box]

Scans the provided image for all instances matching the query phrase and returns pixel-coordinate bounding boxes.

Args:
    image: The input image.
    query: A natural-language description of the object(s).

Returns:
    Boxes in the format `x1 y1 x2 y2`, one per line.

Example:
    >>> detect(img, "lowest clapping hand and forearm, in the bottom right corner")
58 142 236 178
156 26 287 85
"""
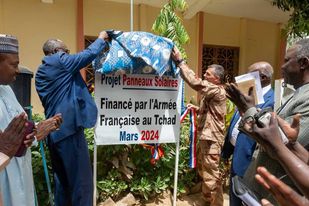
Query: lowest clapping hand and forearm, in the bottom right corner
255 167 309 206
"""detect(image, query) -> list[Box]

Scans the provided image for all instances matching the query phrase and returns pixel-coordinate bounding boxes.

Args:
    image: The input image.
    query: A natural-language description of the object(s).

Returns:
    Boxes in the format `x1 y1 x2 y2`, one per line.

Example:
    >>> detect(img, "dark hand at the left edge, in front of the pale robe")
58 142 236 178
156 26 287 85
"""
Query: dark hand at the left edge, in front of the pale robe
0 112 27 157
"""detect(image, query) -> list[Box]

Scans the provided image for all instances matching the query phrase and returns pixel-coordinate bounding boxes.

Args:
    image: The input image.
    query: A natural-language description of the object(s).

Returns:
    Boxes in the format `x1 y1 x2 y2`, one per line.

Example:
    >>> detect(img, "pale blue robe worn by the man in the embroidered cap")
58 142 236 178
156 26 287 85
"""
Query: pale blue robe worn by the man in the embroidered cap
0 85 35 206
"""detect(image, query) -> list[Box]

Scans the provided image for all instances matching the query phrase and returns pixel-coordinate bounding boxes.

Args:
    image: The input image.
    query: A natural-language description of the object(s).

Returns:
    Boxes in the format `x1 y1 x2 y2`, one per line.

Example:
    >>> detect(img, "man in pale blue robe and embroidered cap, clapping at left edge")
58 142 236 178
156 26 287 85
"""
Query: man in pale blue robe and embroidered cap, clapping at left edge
0 35 61 206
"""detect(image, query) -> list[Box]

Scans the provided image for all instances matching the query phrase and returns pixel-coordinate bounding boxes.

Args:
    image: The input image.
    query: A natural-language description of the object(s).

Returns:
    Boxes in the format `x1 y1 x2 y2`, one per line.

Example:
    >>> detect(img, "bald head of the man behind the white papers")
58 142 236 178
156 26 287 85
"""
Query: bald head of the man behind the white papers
248 62 274 87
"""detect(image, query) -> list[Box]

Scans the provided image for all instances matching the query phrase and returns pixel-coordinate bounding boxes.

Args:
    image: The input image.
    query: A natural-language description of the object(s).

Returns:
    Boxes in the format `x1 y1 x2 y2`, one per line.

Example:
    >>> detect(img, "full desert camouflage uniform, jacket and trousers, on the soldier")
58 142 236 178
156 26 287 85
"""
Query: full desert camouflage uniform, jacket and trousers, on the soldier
181 68 226 206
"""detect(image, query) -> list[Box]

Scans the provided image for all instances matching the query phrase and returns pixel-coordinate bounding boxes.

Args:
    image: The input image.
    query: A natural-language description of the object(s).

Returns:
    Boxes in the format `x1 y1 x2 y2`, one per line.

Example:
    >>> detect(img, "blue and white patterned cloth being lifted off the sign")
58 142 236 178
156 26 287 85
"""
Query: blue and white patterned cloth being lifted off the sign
93 31 178 76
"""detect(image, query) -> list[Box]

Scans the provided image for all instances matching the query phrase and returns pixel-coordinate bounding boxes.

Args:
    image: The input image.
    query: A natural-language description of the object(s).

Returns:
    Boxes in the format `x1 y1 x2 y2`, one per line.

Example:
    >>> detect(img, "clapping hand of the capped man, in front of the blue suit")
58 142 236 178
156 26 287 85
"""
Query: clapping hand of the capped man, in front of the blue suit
36 114 62 141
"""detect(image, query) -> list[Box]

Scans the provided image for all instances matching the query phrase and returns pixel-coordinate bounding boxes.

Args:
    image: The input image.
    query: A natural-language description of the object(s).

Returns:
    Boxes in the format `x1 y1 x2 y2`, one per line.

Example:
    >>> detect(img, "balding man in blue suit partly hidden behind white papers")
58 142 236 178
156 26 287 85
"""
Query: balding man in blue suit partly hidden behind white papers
222 62 274 206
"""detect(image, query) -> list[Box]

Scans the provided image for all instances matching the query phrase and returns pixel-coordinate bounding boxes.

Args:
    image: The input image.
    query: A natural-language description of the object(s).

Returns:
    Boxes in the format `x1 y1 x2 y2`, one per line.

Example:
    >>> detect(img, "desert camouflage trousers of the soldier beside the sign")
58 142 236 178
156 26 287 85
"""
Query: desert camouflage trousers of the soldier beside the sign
197 140 223 206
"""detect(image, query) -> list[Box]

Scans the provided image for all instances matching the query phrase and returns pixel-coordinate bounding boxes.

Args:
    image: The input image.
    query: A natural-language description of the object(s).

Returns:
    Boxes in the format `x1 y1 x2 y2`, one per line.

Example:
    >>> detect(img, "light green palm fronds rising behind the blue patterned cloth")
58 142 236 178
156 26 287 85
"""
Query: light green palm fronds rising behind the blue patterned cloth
152 0 190 58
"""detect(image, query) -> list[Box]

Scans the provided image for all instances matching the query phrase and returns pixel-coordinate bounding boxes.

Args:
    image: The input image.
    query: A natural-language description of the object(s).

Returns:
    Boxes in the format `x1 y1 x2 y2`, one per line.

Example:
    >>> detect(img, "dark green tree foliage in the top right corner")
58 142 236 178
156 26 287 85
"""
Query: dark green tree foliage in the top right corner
272 0 309 37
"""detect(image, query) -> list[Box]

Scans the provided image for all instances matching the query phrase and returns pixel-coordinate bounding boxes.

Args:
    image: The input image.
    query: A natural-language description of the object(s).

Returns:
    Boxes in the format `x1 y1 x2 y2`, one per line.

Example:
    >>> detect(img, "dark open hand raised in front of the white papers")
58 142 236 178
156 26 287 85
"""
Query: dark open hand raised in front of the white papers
225 83 255 114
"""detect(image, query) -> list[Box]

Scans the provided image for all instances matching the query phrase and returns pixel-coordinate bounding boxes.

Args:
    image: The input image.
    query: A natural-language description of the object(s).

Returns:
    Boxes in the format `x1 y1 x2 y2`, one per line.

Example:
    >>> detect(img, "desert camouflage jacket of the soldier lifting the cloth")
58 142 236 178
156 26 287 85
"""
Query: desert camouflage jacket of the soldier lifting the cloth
181 69 226 154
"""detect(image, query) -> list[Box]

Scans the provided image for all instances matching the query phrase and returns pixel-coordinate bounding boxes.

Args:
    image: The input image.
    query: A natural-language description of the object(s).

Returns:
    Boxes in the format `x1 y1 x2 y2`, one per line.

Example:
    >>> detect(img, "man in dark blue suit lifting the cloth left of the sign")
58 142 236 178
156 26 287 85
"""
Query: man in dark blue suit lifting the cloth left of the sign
35 31 108 206
